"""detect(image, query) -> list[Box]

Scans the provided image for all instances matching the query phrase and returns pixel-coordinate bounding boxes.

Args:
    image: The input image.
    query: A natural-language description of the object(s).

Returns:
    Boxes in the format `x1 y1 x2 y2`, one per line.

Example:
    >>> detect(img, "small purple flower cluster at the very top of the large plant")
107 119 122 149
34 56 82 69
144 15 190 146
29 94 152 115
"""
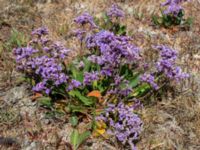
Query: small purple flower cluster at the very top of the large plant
107 4 125 18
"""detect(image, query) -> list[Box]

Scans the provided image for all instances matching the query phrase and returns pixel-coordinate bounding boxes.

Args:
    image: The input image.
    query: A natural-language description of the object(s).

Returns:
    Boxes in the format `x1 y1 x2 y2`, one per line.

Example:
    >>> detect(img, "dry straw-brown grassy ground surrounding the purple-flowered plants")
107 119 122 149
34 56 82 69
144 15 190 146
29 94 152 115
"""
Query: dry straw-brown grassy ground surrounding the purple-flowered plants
0 0 200 150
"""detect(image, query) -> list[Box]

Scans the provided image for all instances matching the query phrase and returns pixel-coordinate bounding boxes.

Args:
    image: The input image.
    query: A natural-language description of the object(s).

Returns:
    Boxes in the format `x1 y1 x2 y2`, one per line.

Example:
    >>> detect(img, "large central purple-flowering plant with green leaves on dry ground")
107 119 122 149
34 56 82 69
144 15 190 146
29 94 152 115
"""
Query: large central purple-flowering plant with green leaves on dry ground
14 5 188 149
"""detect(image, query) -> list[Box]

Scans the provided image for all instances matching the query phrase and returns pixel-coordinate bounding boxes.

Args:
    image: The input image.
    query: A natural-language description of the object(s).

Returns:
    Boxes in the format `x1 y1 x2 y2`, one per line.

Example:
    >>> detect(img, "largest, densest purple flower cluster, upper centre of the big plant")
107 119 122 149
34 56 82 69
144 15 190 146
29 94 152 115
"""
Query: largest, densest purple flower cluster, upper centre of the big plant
86 30 140 69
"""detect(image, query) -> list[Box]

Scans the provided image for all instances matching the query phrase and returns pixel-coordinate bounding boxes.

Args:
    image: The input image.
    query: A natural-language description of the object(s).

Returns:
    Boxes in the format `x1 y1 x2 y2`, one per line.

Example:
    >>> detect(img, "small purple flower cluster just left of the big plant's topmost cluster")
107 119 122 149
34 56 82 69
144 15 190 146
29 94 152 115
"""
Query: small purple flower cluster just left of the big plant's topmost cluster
74 12 97 28
